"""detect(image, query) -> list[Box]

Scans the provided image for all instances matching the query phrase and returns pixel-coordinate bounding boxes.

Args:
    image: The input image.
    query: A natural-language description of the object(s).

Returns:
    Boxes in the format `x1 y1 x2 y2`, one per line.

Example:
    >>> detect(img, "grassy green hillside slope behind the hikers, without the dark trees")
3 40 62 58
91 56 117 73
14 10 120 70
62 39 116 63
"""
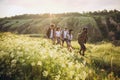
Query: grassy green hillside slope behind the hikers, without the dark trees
0 16 102 42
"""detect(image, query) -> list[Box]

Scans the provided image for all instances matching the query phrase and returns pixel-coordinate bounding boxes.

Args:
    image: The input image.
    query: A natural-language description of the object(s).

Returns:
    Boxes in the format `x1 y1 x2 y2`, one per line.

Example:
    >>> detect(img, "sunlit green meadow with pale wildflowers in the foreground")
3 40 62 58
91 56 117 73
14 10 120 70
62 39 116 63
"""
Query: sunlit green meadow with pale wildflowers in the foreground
0 32 120 80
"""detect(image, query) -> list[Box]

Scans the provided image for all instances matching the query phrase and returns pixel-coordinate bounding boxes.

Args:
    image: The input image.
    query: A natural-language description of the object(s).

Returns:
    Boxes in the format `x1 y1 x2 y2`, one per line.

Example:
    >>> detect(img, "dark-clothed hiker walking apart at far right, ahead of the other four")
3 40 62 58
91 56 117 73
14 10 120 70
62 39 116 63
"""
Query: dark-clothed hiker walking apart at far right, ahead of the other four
78 28 88 56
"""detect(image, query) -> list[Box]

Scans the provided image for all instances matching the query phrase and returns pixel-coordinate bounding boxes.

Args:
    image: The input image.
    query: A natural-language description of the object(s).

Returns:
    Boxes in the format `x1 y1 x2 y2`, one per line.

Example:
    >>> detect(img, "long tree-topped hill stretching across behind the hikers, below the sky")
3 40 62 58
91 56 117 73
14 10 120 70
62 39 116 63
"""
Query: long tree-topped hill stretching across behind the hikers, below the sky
0 10 120 42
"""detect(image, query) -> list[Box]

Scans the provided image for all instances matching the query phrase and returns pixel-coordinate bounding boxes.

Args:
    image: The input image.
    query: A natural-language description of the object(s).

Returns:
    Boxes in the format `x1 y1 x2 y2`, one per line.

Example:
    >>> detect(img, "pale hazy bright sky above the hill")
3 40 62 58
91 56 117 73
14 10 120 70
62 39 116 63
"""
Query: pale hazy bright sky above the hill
0 0 120 17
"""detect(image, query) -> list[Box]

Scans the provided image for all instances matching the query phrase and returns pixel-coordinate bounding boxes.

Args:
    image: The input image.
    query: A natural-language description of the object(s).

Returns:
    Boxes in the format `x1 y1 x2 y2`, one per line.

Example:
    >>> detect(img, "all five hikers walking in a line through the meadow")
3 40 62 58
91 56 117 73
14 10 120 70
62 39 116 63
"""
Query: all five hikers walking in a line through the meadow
47 24 88 56
